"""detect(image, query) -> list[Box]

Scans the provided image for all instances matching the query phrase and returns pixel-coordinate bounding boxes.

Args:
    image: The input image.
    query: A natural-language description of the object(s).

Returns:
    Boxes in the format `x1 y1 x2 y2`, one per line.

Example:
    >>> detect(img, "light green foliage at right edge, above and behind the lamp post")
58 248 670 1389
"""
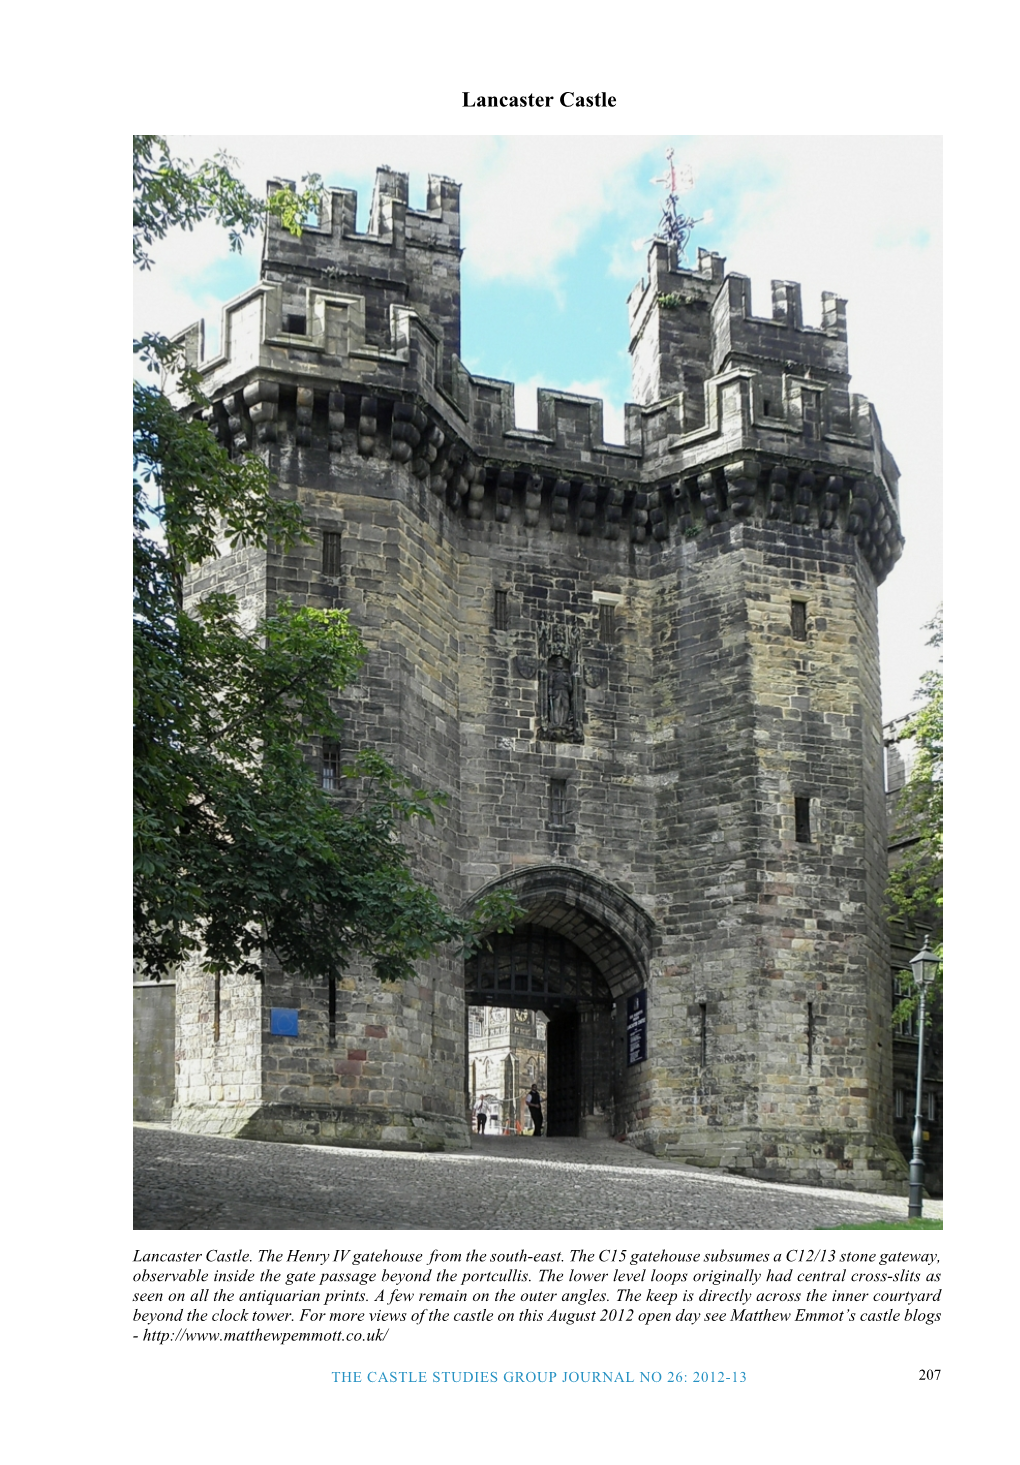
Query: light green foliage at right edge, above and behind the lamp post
888 607 942 1023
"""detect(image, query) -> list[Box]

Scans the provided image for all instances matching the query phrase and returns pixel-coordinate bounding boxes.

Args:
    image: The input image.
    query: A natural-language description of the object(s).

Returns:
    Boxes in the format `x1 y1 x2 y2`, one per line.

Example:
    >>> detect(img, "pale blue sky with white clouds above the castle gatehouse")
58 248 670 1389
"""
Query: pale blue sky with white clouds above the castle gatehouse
135 135 942 721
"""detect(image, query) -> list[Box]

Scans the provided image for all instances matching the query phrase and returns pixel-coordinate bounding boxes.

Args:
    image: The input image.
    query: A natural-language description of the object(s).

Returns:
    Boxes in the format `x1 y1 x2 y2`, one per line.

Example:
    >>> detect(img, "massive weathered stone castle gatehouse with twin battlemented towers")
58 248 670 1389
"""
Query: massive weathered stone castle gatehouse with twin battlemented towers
165 168 904 1190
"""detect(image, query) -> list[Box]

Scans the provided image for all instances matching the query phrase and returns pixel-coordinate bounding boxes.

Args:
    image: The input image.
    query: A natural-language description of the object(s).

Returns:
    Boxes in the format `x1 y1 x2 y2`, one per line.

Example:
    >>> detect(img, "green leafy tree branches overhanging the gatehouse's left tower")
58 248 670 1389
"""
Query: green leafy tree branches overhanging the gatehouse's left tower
133 136 516 980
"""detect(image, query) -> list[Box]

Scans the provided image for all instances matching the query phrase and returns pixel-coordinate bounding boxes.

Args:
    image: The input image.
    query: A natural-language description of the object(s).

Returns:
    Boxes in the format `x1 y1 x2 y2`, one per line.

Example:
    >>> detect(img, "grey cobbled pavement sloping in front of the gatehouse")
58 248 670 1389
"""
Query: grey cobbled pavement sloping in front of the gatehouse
135 1125 941 1231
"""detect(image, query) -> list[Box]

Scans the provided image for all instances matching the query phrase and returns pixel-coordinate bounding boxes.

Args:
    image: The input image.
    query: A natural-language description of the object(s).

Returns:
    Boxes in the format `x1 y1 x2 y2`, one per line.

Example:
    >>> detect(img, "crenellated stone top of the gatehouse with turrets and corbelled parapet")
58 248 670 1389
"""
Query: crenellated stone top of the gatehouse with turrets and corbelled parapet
171 168 903 579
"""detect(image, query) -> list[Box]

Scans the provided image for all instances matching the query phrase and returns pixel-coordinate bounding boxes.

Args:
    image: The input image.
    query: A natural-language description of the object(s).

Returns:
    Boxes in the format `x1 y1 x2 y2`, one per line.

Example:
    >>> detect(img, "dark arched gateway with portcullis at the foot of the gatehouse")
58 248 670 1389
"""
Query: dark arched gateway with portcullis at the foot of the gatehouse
465 866 652 1137
